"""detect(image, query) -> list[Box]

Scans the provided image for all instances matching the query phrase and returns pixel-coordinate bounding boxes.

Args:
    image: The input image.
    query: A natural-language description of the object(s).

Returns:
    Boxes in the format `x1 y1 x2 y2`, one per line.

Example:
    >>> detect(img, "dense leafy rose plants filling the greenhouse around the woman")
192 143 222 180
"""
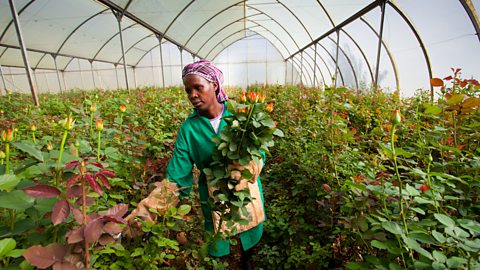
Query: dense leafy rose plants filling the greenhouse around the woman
0 69 480 269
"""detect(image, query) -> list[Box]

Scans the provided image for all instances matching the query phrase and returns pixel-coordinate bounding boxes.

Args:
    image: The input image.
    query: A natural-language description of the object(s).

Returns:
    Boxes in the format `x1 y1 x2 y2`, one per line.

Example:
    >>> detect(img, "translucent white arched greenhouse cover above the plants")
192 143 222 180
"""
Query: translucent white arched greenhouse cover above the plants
0 0 480 95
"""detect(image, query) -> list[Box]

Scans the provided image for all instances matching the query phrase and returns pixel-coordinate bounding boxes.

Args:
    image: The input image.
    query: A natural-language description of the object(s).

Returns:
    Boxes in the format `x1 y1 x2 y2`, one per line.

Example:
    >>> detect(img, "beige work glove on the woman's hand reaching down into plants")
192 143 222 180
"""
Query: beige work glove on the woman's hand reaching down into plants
123 179 180 237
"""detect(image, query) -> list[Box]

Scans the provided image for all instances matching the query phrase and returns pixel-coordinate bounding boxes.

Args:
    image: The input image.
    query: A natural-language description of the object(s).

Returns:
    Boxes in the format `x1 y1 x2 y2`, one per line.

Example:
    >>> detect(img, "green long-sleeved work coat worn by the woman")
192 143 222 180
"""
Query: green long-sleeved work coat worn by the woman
167 104 265 257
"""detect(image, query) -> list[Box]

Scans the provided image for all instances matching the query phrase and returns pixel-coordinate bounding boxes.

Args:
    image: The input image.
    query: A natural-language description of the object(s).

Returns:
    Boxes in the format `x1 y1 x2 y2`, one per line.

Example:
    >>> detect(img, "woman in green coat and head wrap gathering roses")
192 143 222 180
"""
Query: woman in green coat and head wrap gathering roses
126 60 265 269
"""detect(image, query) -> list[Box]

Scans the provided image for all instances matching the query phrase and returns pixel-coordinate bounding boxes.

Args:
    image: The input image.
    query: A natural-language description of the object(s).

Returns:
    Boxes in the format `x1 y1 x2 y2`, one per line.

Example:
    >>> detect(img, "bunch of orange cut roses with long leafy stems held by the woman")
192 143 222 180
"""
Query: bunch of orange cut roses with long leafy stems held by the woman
204 92 284 234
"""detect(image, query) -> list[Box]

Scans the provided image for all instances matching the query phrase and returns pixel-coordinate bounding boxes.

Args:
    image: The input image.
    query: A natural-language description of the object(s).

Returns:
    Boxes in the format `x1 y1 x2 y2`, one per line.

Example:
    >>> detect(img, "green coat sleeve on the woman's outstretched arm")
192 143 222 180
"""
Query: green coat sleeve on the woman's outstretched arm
166 126 193 197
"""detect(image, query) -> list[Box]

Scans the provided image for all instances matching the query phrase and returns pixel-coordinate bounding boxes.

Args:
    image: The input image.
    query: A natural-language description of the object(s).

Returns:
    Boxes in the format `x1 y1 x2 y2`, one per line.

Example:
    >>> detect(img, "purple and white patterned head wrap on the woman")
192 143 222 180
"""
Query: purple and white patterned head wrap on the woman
182 59 228 103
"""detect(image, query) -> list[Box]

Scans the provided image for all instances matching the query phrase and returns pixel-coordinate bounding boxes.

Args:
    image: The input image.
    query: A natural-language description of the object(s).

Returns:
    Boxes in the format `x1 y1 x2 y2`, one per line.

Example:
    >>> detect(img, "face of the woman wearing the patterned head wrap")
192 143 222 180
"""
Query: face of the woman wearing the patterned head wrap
183 74 218 112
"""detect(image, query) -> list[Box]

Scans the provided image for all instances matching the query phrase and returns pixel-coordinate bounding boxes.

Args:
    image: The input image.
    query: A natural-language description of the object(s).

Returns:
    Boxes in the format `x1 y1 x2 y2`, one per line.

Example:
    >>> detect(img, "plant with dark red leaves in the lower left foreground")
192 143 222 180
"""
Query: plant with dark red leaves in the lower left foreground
23 160 128 269
